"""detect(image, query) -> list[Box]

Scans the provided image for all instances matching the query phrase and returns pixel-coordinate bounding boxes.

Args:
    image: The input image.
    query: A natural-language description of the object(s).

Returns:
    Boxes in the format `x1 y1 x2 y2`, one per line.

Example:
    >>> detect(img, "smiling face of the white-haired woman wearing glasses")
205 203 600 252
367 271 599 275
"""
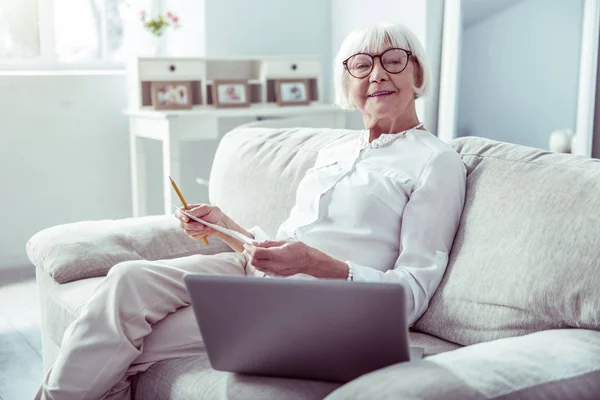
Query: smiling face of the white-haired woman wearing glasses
348 46 418 129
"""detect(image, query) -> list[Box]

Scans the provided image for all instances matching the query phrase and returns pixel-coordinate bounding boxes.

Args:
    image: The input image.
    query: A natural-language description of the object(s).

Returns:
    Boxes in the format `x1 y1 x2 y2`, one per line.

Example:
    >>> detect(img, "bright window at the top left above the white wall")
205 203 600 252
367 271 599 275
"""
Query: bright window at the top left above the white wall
0 0 137 66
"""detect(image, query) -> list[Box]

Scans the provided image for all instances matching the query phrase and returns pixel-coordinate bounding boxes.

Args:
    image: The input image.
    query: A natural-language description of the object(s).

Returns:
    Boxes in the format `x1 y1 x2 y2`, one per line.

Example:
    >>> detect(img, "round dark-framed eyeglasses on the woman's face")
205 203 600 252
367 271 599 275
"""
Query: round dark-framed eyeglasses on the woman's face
342 48 412 79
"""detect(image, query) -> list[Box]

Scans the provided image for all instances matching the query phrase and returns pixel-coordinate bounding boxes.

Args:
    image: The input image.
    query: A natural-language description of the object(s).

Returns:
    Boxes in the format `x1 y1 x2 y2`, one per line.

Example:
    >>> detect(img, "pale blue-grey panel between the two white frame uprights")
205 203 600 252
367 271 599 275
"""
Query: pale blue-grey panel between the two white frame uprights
458 0 583 148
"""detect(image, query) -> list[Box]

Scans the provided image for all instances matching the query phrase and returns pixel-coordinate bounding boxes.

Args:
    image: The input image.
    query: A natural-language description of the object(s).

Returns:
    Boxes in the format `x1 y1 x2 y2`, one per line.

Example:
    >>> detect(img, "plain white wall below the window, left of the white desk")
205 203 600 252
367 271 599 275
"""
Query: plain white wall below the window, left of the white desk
0 75 131 267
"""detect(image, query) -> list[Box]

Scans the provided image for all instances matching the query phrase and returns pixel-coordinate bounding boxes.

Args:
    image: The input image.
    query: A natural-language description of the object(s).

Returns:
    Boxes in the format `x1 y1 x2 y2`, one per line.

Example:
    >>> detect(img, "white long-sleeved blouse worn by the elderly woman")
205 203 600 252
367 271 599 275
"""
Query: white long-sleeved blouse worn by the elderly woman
250 129 466 326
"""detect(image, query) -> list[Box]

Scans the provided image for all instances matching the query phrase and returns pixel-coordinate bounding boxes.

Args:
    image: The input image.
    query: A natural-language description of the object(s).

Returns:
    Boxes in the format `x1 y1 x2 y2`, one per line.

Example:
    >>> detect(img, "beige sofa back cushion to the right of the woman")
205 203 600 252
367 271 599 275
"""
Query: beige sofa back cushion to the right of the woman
415 138 600 345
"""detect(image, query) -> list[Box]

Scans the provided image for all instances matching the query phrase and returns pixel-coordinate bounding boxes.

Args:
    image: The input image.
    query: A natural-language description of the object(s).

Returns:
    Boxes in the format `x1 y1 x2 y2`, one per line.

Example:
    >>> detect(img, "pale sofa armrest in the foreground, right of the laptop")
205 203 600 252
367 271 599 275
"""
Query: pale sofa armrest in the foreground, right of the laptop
325 329 600 400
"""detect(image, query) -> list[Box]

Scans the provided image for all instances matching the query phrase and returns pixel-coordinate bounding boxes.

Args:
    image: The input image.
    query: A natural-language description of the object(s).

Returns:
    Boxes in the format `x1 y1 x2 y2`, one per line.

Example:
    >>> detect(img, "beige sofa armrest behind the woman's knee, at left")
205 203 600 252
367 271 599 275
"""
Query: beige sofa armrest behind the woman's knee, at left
27 215 232 283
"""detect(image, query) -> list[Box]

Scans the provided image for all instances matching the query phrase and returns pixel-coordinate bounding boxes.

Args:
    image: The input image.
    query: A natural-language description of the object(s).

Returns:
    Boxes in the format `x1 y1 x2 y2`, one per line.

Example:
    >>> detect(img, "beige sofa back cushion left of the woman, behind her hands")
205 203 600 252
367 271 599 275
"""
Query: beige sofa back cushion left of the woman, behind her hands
209 127 358 237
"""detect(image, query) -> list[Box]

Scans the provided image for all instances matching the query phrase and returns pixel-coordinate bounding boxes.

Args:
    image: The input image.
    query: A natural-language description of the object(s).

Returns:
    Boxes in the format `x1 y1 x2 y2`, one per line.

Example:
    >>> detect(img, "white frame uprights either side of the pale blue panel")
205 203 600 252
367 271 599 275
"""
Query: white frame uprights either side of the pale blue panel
438 0 600 153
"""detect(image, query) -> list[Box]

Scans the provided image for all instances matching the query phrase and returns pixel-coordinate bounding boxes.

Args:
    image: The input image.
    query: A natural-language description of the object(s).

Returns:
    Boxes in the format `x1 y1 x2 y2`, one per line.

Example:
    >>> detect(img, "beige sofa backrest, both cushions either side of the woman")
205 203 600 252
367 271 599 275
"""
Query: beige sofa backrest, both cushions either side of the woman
210 128 600 345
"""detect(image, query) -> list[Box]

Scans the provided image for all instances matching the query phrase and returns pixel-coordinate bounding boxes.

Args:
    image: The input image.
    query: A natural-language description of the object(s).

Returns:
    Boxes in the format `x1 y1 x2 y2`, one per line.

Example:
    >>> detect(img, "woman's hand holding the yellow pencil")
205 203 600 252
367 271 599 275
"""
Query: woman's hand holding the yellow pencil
175 204 230 240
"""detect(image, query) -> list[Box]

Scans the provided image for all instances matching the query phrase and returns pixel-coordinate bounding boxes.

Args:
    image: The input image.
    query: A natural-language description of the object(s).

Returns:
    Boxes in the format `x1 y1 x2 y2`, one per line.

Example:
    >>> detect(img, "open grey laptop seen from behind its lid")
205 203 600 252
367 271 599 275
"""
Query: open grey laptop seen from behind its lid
185 274 423 382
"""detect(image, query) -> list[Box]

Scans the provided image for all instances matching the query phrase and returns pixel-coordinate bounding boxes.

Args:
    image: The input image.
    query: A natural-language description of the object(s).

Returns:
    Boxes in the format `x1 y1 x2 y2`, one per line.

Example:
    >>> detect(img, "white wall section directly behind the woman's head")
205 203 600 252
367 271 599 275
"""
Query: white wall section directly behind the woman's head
331 0 428 129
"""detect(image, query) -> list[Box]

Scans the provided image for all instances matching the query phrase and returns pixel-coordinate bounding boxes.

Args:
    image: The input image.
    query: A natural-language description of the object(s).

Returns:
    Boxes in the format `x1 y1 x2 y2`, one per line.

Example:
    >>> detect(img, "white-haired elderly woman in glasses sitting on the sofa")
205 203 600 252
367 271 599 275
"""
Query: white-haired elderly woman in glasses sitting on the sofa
39 24 465 400
